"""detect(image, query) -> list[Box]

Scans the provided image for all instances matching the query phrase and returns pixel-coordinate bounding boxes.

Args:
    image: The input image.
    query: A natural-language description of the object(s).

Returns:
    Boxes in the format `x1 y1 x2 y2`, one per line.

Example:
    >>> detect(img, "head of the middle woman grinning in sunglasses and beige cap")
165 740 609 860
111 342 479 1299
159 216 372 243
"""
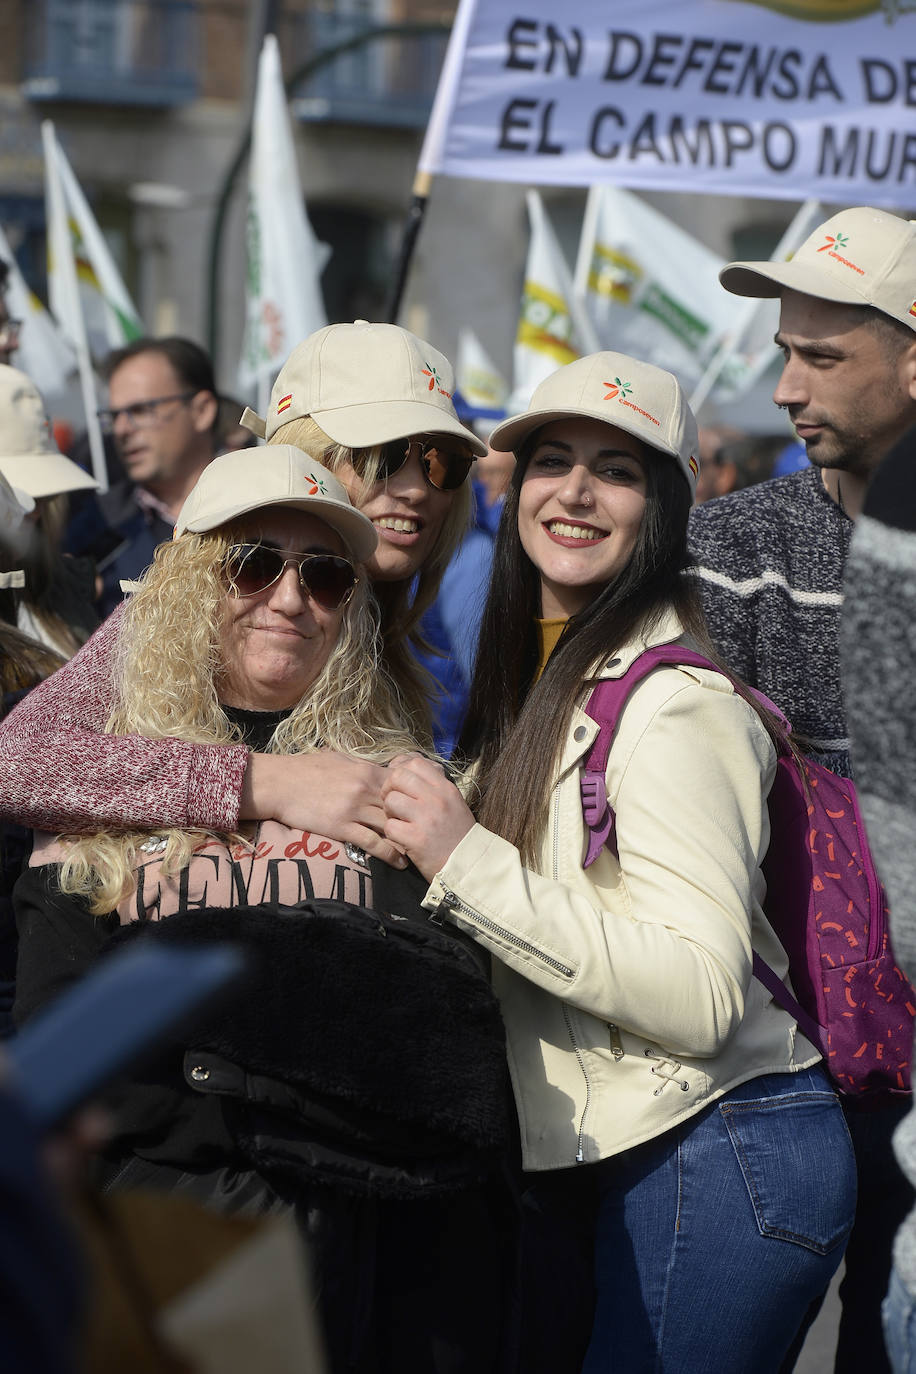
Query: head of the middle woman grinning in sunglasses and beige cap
242 320 486 734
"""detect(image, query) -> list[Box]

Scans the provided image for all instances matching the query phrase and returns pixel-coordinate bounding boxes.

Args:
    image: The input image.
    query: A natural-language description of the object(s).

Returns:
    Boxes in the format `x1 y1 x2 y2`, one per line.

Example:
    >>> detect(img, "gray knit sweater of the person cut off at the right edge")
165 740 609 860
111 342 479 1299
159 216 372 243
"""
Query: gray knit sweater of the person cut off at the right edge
840 429 916 1297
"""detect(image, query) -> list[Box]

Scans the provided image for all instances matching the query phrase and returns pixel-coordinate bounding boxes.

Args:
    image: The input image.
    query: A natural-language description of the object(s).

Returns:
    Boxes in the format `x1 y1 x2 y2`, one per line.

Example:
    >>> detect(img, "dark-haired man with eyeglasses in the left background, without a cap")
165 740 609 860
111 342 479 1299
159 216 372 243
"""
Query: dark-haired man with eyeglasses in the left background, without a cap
99 337 218 611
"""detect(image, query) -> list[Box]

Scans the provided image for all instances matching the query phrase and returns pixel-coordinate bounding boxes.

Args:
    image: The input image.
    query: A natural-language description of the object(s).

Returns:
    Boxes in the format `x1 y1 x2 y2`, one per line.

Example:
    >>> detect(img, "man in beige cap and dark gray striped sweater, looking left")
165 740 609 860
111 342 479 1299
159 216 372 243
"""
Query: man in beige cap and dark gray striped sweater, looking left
689 207 916 1374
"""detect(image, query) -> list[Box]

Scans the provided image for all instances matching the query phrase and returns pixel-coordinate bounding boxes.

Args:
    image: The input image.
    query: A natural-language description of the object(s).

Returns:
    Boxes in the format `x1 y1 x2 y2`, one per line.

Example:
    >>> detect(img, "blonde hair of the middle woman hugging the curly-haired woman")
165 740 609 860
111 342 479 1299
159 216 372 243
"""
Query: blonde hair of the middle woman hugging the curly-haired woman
268 415 471 746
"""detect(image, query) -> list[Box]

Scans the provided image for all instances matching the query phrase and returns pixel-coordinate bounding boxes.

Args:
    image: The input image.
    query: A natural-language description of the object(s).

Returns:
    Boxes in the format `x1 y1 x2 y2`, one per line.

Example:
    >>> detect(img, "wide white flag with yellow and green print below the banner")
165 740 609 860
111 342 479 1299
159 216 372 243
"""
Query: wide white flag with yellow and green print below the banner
575 185 739 389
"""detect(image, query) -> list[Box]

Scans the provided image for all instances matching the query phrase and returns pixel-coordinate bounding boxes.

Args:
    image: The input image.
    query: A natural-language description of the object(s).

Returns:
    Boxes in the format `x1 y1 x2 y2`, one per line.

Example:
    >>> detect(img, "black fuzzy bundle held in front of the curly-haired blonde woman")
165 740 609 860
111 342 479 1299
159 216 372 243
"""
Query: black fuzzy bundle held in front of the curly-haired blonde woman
115 875 509 1197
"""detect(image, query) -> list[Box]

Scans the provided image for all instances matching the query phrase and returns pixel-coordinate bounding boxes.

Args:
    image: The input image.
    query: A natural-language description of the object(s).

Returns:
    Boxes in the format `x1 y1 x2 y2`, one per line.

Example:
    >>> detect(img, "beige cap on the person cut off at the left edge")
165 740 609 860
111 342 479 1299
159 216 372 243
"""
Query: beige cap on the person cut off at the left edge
0 364 99 500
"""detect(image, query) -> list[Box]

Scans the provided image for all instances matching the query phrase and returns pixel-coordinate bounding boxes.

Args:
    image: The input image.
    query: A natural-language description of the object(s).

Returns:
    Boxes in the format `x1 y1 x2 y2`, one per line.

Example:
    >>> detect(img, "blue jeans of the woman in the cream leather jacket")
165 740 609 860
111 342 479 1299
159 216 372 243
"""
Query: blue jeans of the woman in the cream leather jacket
582 1066 856 1374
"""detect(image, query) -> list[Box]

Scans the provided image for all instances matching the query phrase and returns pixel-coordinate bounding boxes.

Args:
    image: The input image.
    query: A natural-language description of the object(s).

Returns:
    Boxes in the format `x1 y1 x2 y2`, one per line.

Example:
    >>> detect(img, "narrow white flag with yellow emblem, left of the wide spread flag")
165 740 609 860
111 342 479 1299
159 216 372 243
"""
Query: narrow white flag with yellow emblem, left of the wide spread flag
507 191 600 414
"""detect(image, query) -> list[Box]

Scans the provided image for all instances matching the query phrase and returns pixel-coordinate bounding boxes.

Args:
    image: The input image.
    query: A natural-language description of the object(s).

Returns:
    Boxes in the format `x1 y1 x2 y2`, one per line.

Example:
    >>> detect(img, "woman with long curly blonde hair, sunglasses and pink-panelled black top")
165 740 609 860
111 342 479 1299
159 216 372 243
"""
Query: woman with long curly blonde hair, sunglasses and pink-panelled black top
14 444 512 1374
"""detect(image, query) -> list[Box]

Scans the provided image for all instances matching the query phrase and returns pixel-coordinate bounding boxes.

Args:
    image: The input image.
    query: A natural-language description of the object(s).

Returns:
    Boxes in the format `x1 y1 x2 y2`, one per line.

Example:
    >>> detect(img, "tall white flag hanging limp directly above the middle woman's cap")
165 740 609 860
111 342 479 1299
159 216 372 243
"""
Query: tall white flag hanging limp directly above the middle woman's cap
239 33 330 393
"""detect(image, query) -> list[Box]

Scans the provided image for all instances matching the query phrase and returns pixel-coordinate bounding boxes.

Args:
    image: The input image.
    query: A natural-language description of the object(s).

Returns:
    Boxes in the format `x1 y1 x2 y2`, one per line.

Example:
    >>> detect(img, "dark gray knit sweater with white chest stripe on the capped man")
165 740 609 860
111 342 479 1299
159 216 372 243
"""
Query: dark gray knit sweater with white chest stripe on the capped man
688 467 853 778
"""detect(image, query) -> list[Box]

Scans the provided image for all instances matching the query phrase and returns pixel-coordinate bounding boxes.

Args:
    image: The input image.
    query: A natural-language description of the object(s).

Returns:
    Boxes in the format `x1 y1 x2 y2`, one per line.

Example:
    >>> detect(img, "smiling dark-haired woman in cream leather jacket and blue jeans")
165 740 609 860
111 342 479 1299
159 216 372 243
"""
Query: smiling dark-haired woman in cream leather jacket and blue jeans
383 353 856 1374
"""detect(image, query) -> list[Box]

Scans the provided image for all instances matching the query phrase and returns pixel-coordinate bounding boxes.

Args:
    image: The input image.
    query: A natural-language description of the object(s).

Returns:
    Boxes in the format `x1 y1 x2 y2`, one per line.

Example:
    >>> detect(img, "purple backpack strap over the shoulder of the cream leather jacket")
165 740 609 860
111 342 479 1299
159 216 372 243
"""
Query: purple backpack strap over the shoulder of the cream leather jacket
580 644 720 868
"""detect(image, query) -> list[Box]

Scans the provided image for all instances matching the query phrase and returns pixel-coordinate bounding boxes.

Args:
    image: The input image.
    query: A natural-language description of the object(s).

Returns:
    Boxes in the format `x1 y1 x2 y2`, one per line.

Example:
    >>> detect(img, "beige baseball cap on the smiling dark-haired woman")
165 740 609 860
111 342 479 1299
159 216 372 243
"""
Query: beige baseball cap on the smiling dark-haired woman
490 353 699 493
